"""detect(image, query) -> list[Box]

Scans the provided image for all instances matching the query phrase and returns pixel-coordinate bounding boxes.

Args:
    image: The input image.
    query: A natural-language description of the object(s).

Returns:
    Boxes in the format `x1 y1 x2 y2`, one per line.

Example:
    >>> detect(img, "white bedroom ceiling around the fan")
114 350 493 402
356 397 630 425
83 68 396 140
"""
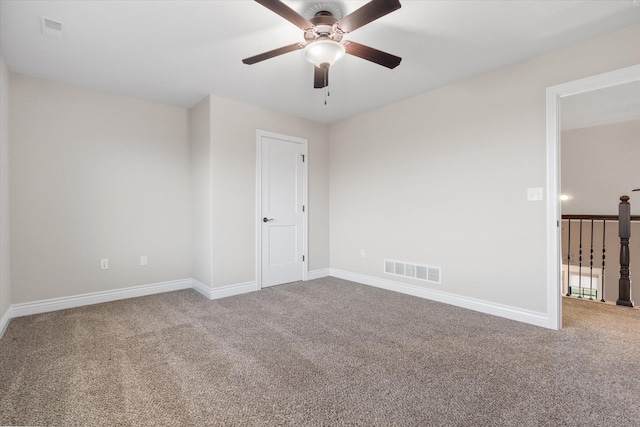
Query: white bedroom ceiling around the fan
0 0 640 123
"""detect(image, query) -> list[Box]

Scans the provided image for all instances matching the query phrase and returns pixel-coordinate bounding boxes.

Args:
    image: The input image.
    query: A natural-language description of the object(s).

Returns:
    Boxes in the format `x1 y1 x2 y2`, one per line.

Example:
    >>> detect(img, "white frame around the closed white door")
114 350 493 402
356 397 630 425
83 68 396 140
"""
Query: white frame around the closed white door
255 129 309 290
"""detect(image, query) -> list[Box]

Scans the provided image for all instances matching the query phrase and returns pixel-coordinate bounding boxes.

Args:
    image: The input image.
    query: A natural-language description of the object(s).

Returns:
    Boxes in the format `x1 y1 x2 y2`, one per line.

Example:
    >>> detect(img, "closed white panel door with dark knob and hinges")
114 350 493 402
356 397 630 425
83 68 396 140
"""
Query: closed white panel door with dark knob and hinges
258 133 306 287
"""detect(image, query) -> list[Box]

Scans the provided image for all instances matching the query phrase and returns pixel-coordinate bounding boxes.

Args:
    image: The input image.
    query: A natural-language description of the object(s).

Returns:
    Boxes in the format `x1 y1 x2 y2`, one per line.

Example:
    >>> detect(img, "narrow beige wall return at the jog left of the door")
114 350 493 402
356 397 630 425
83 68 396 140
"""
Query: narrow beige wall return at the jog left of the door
189 97 213 286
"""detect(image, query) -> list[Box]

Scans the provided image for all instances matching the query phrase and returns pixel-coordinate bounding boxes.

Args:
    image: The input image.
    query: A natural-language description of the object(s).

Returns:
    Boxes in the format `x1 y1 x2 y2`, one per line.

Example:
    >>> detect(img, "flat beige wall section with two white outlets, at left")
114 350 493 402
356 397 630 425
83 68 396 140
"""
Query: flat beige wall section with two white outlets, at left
10 74 192 304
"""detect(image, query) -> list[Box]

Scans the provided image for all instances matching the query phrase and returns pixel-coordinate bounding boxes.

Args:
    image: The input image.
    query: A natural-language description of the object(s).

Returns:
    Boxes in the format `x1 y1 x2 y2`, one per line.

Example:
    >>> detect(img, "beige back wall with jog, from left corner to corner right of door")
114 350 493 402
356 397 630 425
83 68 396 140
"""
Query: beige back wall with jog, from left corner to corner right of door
11 75 329 303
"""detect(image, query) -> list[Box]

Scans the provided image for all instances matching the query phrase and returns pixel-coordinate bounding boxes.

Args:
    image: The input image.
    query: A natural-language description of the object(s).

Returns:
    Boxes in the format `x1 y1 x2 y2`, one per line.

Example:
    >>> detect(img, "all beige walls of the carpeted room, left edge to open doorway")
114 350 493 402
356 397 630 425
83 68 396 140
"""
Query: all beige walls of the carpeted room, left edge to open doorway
0 22 640 320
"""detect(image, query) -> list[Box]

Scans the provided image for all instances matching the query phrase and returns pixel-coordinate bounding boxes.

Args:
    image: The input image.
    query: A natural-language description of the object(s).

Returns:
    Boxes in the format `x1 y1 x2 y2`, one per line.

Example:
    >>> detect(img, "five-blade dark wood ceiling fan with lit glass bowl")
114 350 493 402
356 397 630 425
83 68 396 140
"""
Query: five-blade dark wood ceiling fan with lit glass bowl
242 0 402 89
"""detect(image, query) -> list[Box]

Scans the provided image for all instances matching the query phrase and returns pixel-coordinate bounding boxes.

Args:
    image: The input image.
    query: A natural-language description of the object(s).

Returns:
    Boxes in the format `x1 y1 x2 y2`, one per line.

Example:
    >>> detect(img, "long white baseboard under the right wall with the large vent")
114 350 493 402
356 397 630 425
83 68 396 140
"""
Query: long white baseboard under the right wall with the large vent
331 268 552 329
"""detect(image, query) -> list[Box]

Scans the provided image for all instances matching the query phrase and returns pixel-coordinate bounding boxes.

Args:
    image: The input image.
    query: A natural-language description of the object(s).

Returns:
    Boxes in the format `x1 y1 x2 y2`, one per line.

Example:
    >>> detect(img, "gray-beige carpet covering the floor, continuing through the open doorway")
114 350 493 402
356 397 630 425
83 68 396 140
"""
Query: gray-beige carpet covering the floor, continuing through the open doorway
0 278 640 426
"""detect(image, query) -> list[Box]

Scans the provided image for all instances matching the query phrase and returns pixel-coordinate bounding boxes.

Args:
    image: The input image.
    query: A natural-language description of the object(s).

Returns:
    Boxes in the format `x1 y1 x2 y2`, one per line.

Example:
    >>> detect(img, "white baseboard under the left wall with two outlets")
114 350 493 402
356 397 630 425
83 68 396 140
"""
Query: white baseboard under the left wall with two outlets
11 279 192 318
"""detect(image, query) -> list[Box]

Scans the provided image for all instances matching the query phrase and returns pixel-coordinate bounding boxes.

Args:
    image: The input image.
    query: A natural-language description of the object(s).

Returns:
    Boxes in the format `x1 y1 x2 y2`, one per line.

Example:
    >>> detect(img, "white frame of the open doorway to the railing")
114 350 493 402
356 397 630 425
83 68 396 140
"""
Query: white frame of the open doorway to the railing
547 65 640 330
